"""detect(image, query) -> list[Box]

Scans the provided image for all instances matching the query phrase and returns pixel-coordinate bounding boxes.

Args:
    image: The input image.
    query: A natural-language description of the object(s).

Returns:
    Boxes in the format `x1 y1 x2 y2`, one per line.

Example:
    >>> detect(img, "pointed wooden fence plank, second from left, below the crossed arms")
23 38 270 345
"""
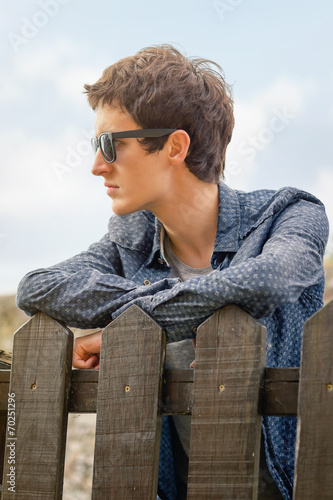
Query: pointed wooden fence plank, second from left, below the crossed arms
92 306 164 500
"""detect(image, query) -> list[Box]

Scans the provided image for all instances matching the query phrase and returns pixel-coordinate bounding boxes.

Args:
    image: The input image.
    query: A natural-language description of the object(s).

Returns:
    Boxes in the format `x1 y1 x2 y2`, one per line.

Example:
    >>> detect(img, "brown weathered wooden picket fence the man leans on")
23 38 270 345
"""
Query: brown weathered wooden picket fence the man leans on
0 302 333 500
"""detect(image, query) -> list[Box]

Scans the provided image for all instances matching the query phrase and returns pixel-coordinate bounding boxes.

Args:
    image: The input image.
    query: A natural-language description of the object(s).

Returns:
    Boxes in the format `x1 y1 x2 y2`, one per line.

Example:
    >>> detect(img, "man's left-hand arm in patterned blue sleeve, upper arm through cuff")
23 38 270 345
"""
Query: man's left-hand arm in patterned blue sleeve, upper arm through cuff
17 234 177 328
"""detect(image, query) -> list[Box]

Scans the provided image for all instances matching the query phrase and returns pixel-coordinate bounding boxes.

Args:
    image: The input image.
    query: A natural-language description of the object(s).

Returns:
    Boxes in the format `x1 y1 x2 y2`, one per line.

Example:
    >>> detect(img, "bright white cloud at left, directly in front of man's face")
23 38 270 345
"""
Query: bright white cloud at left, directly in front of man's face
0 129 97 216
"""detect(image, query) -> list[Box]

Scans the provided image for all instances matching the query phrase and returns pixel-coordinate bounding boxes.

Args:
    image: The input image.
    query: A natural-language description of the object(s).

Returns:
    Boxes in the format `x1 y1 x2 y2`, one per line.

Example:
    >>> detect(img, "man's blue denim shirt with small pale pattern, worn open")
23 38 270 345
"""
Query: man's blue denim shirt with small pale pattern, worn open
17 182 328 499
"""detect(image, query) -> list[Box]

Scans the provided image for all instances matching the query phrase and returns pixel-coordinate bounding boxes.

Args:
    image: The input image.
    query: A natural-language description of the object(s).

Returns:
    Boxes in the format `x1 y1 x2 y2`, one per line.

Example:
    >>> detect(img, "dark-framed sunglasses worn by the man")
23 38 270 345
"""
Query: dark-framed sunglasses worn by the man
91 128 177 163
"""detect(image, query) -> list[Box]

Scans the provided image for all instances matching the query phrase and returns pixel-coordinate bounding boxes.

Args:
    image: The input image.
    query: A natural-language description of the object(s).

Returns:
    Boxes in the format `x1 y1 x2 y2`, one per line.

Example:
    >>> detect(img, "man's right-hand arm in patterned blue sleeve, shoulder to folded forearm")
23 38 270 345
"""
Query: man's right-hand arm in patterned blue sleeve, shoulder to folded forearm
113 200 328 341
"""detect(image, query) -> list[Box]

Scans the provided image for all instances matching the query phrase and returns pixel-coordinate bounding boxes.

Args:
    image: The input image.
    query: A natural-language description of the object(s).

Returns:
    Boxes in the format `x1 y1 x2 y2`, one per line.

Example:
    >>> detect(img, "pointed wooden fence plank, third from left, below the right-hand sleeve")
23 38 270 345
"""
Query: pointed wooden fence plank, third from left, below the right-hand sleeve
187 306 266 500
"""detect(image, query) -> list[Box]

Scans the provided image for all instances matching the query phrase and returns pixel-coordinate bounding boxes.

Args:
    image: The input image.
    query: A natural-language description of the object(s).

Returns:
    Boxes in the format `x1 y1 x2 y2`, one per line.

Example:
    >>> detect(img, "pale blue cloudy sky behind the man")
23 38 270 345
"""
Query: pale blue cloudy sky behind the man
0 0 333 294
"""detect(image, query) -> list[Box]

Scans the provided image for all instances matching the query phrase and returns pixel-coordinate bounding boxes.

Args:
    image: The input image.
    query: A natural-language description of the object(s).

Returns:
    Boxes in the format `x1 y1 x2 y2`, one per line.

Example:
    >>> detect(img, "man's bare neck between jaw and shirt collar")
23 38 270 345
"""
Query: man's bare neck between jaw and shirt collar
155 179 219 268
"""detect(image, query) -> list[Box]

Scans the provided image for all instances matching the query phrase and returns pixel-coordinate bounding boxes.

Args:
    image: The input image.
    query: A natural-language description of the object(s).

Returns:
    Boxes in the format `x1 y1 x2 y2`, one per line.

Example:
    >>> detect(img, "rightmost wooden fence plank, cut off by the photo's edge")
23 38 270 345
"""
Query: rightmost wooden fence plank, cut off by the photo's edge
293 301 333 500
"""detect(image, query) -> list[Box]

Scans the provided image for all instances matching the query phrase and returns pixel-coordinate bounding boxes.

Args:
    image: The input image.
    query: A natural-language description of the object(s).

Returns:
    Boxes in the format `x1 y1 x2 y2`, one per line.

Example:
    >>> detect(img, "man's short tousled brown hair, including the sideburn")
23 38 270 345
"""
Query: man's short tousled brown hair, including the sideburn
85 45 234 183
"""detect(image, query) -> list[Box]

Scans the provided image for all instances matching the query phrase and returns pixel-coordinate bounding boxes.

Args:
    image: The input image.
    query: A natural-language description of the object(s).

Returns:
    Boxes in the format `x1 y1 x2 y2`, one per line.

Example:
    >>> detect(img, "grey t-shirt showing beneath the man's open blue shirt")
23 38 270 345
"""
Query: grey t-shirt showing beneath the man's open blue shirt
161 230 213 456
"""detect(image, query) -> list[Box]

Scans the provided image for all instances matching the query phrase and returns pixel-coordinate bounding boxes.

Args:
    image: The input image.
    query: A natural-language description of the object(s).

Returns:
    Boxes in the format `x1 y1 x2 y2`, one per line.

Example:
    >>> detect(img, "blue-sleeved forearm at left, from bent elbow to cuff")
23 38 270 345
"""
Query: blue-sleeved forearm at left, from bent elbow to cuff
17 268 179 328
